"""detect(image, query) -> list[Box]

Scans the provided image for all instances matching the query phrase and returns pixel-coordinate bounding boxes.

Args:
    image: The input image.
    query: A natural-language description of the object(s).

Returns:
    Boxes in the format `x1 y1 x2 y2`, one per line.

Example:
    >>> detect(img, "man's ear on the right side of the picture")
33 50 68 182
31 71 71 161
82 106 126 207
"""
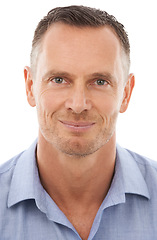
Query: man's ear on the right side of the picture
120 73 135 113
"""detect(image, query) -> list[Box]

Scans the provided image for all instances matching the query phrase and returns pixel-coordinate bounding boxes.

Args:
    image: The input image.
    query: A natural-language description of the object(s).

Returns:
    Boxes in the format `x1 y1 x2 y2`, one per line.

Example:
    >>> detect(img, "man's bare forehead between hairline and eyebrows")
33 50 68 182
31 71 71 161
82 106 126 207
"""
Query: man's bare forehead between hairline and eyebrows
40 24 121 64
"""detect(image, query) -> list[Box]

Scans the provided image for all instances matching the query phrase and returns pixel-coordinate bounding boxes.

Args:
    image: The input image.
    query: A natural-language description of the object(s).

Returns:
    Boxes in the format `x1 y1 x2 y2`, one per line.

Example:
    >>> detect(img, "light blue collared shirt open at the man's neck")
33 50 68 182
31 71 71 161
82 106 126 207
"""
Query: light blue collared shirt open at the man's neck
0 142 157 240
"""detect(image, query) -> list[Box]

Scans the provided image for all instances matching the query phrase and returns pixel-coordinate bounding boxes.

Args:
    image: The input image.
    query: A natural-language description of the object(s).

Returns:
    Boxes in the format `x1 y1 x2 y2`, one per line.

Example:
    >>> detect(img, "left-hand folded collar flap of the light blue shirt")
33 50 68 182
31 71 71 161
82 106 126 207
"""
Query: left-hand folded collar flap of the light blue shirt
8 140 42 207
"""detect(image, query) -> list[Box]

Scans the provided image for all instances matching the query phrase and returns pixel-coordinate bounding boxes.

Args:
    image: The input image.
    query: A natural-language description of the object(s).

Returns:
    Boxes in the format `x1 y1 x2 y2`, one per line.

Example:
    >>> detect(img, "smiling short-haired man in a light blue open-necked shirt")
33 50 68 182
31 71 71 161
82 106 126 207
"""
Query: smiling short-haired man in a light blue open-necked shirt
0 6 157 240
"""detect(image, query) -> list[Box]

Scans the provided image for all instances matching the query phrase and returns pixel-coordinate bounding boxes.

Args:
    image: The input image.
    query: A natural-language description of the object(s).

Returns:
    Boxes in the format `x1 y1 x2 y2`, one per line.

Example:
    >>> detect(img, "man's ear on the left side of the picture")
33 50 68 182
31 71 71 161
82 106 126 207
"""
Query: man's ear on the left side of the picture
24 66 36 107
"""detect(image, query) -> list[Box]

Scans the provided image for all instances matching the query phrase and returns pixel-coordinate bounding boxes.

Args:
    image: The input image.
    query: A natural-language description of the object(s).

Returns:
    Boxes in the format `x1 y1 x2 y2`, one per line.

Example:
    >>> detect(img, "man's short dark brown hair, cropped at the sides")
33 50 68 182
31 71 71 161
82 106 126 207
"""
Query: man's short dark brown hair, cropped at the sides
31 5 130 76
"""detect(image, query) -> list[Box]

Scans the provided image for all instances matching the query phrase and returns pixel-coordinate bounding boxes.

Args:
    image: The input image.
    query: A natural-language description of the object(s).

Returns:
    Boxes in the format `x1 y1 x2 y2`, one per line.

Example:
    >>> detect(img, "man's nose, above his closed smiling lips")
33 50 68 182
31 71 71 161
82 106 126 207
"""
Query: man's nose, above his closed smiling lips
65 86 92 114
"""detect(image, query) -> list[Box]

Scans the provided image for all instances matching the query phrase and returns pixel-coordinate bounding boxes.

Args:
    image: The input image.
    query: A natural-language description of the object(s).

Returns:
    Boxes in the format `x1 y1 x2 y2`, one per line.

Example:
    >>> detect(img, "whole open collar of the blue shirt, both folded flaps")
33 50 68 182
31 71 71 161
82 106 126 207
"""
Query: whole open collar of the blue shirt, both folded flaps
8 140 150 208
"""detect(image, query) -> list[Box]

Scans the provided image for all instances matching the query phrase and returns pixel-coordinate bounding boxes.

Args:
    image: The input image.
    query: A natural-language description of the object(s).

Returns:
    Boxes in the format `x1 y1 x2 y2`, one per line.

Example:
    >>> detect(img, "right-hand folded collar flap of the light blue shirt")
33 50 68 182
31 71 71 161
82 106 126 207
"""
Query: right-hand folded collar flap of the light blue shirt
100 144 150 209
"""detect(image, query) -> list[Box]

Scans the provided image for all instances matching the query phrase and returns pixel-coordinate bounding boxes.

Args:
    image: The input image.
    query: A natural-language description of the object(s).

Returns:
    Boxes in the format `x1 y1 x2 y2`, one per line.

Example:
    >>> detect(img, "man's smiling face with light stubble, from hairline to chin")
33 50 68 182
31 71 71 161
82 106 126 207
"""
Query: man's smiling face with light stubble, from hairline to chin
25 23 134 156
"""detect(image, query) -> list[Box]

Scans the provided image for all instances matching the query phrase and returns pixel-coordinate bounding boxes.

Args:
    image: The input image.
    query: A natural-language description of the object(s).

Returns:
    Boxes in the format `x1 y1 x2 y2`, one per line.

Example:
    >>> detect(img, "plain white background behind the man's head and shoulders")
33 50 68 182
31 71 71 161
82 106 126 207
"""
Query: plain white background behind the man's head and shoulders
0 0 157 163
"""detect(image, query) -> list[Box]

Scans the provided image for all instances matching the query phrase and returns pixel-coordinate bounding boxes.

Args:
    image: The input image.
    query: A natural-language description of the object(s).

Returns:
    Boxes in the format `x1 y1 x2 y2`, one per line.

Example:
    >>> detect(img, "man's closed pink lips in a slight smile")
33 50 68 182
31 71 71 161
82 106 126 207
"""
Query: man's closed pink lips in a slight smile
60 121 95 132
